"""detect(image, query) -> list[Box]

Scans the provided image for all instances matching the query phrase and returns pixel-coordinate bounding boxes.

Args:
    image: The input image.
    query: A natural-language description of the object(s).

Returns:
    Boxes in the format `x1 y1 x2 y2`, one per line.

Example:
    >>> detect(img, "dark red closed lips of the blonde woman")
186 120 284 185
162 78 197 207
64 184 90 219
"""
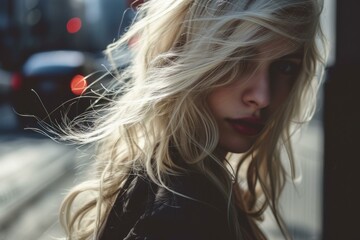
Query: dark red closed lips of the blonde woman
227 117 265 136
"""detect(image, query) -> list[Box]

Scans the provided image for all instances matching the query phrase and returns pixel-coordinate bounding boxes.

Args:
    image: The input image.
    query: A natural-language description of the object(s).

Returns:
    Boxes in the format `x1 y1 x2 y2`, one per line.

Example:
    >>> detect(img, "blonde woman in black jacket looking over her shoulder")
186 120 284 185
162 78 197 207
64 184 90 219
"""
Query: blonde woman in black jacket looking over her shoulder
61 0 323 240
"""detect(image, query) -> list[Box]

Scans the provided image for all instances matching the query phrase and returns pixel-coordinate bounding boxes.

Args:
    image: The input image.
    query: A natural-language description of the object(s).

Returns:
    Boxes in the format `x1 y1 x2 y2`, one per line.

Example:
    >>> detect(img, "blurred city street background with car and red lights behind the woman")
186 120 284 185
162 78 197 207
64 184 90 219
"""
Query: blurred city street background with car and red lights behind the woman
0 0 336 240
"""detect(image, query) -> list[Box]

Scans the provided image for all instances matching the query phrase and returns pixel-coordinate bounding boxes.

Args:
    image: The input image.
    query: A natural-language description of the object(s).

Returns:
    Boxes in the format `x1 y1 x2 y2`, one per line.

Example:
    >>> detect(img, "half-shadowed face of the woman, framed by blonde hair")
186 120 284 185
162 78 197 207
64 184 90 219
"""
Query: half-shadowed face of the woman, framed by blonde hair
207 41 302 154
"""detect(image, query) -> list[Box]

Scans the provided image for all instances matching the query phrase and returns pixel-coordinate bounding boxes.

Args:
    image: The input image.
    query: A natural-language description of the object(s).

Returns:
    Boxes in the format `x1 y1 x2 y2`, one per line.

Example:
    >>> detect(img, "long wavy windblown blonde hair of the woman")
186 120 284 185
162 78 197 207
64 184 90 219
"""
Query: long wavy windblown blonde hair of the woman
60 0 324 240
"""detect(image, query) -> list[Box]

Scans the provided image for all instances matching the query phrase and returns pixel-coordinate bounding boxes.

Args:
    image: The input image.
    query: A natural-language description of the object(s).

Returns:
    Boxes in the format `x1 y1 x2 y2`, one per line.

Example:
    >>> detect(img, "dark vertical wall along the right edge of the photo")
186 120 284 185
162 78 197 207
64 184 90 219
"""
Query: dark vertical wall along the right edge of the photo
323 0 360 240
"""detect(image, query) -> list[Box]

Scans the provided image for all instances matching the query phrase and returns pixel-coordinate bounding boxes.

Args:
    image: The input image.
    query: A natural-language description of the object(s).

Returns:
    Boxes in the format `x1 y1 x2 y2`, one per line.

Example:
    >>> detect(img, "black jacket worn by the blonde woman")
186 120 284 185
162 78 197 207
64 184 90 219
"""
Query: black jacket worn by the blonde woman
100 174 238 240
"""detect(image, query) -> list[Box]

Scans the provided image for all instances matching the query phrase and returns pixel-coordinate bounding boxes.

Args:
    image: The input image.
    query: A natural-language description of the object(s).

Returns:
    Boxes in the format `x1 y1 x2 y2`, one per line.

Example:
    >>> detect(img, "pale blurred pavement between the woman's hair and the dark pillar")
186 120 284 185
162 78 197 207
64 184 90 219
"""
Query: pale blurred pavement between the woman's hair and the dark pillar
263 121 323 240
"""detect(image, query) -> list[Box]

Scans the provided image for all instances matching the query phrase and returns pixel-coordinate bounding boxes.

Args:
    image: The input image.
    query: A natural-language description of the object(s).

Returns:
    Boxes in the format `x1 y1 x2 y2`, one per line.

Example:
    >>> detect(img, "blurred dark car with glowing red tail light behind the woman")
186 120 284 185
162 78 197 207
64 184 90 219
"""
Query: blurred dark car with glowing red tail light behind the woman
12 50 107 127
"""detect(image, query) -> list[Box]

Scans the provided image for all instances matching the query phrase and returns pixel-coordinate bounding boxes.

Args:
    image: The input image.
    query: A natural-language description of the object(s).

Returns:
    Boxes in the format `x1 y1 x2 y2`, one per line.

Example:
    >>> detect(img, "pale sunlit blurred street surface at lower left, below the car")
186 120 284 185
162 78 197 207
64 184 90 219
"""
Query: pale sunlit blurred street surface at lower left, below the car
0 130 91 240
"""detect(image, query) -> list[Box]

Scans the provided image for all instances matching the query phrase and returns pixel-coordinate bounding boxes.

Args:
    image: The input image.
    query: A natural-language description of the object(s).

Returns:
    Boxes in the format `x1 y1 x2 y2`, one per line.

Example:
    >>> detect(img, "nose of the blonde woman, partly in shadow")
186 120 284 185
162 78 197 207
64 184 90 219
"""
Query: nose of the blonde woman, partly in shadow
243 69 270 109
